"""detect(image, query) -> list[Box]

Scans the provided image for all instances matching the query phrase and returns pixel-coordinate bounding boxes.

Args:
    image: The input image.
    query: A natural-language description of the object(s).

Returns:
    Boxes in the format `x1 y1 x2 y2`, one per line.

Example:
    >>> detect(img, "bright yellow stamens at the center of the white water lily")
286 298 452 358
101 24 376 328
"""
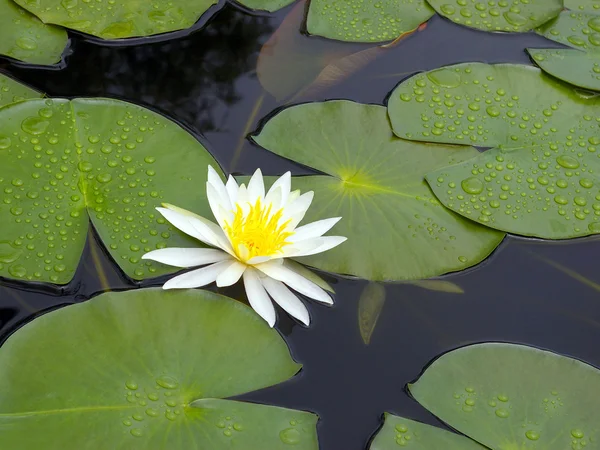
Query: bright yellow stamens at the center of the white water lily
225 199 294 262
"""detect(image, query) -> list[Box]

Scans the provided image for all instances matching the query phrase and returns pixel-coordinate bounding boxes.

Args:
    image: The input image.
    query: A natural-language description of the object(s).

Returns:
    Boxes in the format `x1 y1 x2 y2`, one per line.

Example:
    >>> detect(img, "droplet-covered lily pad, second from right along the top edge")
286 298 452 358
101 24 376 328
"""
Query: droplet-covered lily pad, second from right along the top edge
428 0 563 32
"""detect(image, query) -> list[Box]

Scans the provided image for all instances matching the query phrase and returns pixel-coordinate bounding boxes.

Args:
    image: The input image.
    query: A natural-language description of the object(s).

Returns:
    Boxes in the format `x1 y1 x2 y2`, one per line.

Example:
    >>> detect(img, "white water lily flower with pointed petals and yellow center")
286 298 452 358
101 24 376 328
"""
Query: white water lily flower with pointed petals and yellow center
143 166 346 327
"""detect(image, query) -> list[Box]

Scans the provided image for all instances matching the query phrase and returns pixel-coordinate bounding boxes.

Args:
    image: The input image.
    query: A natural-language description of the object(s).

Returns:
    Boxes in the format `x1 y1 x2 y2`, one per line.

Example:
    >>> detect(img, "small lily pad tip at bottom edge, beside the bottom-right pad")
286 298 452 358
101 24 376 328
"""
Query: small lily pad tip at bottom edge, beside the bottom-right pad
369 413 485 450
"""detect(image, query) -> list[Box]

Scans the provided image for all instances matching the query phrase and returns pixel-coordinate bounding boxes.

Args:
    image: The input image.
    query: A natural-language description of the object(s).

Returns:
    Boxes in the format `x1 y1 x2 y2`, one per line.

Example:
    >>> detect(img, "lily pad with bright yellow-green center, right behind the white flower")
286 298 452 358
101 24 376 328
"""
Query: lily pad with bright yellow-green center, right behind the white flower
254 101 504 281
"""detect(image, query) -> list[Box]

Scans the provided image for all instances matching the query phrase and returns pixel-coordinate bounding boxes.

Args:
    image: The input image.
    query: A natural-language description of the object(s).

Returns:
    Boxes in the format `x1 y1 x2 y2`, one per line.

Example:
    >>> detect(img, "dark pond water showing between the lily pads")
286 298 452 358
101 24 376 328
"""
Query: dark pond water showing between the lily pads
0 1 600 450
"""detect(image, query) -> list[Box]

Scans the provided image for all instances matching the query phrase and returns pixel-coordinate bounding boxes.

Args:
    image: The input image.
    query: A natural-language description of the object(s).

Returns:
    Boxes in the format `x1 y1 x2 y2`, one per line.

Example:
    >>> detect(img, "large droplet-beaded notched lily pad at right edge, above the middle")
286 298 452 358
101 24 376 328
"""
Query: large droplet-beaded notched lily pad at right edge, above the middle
389 63 600 239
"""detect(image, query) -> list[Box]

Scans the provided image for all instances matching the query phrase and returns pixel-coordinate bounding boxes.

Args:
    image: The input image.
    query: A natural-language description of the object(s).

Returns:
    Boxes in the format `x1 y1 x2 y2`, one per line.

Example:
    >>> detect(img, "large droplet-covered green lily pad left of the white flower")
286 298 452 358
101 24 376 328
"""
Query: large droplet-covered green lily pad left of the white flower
0 99 218 284
